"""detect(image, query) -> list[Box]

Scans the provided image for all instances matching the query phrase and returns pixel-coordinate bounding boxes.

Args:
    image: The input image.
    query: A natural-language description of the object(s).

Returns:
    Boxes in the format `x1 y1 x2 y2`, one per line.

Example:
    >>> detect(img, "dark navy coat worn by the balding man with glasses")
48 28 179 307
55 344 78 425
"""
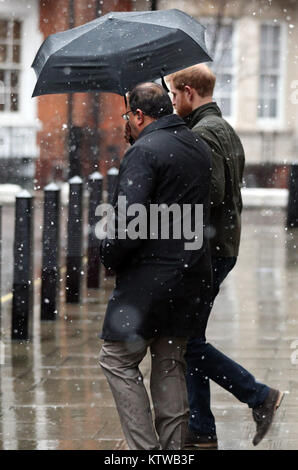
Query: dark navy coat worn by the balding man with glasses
100 115 211 341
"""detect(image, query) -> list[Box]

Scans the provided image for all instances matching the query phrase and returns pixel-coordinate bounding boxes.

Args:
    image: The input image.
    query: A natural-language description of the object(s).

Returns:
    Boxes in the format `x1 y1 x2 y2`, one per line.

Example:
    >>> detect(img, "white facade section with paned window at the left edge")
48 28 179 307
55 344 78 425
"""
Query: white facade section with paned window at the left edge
0 0 41 187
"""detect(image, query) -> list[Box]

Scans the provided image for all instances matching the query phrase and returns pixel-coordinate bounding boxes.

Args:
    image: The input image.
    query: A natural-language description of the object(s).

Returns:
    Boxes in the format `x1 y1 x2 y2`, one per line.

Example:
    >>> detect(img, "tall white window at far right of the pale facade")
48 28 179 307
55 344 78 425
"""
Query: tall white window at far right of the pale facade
258 24 281 119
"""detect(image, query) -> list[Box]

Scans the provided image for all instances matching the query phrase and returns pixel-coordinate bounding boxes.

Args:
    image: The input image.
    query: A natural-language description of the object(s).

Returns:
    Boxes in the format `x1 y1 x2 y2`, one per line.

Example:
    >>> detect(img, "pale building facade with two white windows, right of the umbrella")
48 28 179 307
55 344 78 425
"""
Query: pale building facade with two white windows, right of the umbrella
157 0 298 187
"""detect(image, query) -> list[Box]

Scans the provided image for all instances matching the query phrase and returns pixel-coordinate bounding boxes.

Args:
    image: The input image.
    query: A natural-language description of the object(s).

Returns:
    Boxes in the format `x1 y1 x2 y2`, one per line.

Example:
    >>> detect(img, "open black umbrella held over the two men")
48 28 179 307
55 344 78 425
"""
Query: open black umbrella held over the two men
32 10 211 96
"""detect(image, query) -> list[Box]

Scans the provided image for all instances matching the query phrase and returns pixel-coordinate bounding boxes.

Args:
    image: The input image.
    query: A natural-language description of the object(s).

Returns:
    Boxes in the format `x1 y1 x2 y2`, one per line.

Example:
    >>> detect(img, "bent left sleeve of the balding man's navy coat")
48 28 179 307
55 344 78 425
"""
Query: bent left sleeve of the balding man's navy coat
100 145 156 271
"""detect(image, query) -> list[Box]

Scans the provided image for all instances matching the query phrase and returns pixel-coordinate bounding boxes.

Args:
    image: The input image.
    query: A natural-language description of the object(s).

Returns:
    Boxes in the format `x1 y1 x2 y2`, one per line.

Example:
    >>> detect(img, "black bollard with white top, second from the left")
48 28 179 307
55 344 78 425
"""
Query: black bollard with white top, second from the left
40 183 60 320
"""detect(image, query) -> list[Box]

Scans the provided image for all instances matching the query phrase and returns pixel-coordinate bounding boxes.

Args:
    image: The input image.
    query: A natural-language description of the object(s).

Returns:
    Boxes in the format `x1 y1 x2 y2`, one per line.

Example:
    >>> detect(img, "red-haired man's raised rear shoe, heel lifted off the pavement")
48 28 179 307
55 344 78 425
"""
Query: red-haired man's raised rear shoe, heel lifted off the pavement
252 388 284 446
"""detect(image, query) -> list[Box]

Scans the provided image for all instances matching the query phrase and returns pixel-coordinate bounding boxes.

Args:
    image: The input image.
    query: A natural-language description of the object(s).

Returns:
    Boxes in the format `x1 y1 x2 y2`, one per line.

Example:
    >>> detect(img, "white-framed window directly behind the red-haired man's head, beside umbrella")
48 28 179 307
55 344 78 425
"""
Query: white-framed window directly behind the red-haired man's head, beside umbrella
200 18 234 117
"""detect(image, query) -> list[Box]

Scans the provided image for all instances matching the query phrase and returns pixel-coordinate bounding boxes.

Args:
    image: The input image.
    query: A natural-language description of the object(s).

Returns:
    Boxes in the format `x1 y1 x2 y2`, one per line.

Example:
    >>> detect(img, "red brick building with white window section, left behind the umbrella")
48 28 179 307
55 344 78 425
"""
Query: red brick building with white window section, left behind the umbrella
0 0 150 187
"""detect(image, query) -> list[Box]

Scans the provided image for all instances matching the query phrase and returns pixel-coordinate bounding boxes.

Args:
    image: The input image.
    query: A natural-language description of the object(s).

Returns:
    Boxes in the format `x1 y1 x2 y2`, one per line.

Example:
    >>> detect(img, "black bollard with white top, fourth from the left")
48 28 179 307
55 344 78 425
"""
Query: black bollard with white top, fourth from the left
87 171 102 289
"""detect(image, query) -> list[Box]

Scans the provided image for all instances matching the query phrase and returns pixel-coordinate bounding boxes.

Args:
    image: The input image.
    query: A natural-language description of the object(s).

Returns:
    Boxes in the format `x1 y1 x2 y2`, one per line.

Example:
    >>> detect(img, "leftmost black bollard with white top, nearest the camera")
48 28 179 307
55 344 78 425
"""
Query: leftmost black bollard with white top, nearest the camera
11 190 34 340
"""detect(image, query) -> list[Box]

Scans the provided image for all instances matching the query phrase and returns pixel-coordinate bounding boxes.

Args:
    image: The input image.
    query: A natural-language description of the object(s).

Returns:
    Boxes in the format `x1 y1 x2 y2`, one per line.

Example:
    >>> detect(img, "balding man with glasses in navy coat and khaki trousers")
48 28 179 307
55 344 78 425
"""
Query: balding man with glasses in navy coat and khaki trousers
100 83 211 450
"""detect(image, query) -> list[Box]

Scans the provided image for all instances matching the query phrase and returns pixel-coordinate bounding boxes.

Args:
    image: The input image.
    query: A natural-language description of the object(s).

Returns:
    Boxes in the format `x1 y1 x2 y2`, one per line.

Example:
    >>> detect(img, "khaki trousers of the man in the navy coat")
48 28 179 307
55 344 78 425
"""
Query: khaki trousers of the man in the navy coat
99 338 189 450
